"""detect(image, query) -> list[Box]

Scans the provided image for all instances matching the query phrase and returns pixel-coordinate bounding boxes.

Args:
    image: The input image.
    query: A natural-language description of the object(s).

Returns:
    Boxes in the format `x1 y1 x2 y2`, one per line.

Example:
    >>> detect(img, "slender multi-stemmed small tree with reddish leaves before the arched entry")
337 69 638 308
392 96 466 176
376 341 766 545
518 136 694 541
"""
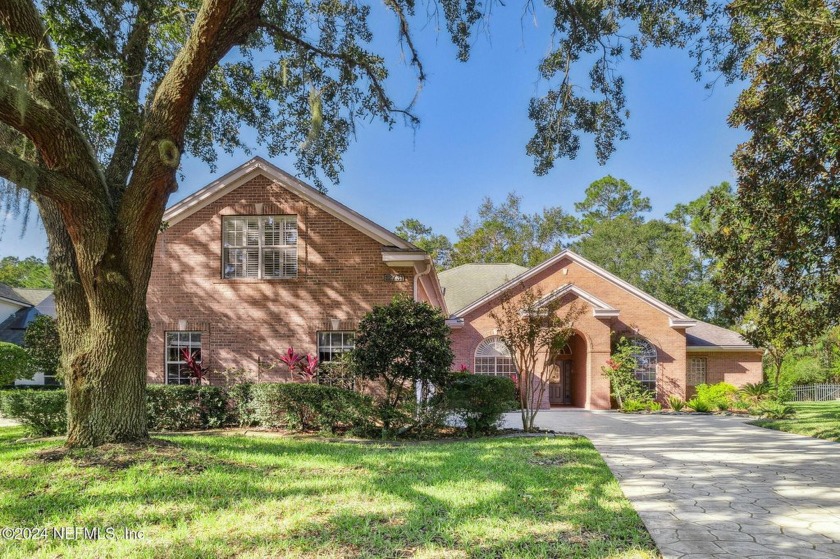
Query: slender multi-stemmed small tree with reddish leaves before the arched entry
490 287 581 431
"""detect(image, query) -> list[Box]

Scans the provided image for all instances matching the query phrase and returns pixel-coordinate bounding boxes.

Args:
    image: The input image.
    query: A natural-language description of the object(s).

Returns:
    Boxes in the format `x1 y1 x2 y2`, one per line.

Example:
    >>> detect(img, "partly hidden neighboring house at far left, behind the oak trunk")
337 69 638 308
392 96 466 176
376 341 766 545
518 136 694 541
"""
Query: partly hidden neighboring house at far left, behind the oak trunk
0 283 58 385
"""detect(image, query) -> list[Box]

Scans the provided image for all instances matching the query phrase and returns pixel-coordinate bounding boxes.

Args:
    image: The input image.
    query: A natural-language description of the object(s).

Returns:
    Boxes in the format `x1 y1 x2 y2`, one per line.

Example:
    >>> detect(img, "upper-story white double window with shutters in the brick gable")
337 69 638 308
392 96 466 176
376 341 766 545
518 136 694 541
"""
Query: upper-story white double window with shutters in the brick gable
222 219 298 279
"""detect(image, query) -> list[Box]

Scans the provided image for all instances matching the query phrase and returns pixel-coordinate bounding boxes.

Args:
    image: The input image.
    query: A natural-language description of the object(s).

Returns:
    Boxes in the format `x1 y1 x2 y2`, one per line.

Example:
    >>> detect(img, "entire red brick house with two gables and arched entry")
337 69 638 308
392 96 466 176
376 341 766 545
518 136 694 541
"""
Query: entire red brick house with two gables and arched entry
147 158 762 409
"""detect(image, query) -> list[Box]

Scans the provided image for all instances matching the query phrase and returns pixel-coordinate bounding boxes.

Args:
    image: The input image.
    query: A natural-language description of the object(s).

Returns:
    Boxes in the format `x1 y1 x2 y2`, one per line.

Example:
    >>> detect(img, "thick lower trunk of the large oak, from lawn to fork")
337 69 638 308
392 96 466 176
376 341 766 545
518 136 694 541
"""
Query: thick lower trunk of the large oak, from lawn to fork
36 195 155 447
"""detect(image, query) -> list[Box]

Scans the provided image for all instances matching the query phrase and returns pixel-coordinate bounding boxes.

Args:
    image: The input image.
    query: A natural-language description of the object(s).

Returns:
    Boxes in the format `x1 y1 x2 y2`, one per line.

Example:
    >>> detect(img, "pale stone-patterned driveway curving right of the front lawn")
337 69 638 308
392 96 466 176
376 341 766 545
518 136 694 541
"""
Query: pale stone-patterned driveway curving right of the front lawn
506 411 840 559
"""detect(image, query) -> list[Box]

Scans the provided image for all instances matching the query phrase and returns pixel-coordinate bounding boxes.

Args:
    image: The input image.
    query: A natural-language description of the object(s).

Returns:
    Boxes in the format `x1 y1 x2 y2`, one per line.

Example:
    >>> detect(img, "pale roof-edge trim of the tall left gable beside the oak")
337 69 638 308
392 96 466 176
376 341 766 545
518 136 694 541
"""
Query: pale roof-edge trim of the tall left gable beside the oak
163 157 422 252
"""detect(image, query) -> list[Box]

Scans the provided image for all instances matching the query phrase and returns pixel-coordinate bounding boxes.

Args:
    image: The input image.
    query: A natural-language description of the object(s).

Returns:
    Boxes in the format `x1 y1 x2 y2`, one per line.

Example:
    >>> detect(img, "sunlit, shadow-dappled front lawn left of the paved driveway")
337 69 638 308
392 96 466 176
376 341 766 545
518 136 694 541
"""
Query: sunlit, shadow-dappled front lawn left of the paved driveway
0 428 659 558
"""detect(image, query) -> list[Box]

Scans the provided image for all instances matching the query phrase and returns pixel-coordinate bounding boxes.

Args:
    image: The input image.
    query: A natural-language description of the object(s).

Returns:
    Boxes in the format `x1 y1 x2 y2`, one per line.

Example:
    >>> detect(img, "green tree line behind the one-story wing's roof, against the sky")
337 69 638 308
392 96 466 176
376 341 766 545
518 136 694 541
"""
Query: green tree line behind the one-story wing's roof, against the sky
396 176 734 326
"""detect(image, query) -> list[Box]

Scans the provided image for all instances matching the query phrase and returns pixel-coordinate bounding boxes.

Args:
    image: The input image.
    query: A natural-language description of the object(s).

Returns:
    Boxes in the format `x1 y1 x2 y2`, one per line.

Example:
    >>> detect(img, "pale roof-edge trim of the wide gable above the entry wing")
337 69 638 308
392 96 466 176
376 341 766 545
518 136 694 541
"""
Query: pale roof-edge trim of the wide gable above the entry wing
454 249 697 328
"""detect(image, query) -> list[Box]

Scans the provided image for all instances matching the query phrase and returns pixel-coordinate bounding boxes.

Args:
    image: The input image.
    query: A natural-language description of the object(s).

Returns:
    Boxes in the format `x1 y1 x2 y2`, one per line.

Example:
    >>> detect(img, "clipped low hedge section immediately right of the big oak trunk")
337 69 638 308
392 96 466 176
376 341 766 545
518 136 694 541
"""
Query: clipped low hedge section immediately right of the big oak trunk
146 384 228 431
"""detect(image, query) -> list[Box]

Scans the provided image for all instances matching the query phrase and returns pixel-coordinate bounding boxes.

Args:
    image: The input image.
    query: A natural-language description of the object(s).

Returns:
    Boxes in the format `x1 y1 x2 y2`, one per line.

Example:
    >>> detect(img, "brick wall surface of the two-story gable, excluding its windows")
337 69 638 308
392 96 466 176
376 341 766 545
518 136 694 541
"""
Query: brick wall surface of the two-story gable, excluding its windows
147 176 413 382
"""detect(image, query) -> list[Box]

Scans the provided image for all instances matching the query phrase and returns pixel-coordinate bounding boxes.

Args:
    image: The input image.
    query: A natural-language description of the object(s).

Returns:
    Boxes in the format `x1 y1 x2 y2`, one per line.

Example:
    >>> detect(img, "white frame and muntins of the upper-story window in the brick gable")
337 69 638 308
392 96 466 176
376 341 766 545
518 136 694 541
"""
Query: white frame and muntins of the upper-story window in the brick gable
222 215 298 279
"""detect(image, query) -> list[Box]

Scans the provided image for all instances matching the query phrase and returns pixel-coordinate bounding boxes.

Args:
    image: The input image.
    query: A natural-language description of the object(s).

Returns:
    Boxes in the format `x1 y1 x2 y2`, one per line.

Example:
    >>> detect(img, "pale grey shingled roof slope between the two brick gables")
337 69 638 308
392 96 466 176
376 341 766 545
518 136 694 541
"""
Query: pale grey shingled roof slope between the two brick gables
438 264 528 315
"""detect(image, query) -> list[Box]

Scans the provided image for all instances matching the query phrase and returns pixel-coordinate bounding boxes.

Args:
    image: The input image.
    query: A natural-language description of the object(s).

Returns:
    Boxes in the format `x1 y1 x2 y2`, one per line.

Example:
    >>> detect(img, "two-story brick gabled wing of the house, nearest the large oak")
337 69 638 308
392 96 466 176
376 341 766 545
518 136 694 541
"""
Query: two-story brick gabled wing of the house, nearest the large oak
147 158 445 384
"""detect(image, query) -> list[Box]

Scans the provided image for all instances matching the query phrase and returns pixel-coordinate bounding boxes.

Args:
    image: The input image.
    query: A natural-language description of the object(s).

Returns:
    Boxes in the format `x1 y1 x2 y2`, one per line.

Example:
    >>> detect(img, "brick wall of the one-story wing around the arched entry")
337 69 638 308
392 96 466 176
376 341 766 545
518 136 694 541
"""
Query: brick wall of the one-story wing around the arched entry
452 258 761 409
